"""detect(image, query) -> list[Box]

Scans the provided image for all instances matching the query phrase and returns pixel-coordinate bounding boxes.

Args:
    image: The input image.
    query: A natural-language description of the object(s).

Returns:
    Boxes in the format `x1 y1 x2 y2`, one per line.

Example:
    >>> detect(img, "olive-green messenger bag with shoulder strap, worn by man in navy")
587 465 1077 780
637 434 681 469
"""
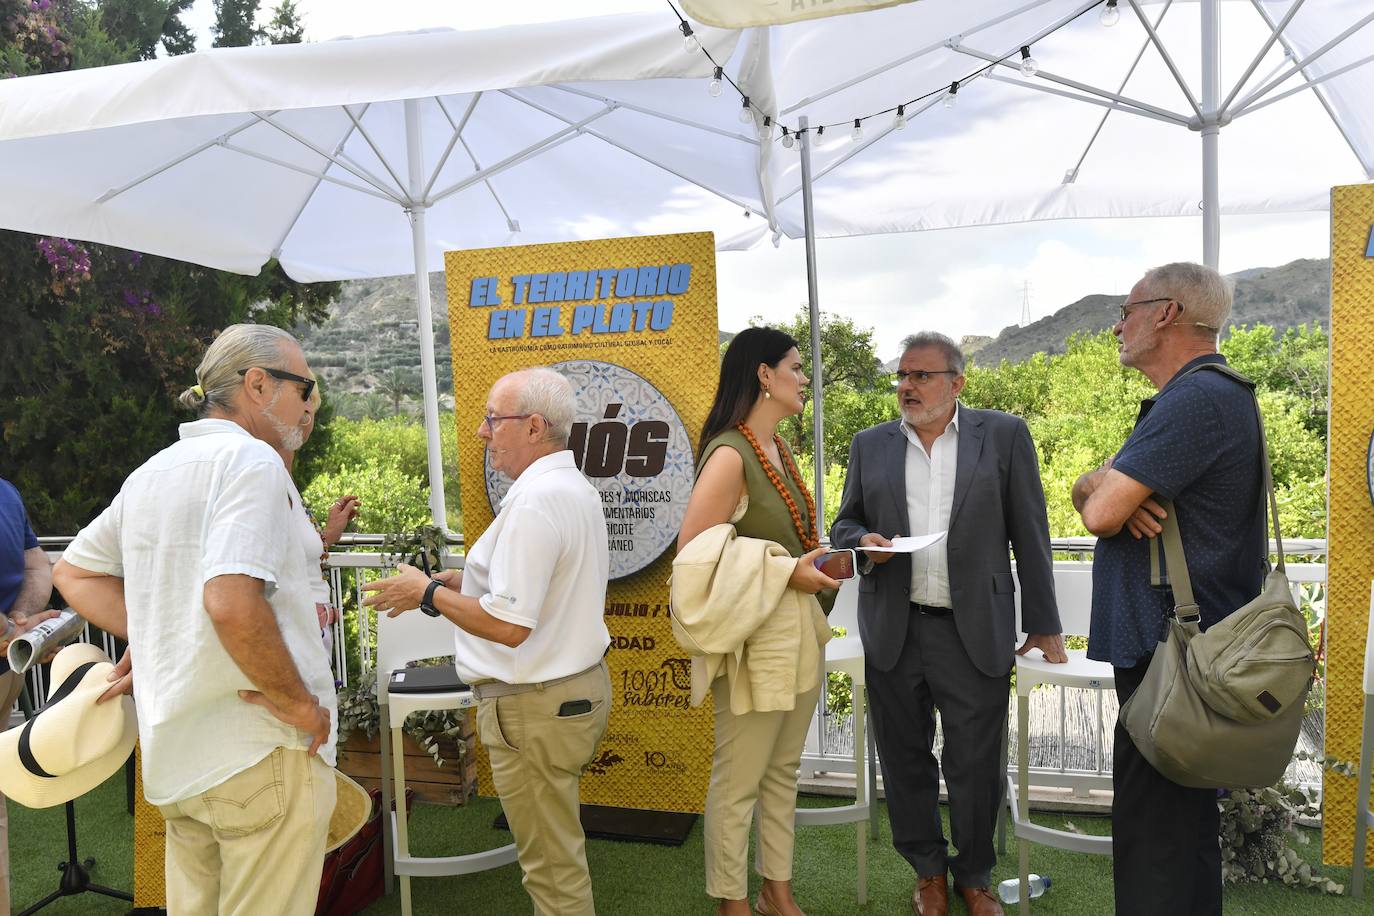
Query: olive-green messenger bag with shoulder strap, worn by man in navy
1120 363 1315 788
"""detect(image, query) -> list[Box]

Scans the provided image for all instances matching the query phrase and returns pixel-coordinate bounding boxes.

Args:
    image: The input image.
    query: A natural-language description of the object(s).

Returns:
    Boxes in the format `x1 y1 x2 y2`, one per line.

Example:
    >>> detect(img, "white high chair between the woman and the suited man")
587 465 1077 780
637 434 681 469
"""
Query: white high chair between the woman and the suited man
796 577 878 906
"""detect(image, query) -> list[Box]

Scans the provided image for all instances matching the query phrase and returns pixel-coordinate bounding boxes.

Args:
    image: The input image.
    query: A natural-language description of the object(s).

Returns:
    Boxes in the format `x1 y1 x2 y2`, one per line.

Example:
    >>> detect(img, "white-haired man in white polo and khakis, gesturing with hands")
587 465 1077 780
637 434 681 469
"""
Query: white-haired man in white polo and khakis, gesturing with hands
364 367 610 916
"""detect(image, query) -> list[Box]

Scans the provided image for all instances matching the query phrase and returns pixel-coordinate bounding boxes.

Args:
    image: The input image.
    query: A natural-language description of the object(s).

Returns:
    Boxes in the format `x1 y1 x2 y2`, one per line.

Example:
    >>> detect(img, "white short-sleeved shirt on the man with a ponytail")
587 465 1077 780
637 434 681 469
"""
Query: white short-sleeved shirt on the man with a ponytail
63 420 338 805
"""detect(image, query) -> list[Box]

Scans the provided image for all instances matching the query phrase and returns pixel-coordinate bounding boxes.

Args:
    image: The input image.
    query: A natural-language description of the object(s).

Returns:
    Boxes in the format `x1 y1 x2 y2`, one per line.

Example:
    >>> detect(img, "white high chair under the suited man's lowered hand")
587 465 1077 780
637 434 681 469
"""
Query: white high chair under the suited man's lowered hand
1007 563 1116 913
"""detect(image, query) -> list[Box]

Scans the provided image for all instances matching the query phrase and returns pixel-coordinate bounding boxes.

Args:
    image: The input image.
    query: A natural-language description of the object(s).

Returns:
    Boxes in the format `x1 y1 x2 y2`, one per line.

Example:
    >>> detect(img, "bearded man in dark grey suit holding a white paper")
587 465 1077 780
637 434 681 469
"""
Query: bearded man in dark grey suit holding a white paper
830 332 1068 916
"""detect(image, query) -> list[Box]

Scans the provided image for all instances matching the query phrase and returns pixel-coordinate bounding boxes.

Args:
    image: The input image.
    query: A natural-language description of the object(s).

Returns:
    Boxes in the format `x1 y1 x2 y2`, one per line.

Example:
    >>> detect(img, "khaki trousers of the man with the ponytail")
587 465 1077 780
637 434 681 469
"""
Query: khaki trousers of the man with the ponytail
158 747 335 916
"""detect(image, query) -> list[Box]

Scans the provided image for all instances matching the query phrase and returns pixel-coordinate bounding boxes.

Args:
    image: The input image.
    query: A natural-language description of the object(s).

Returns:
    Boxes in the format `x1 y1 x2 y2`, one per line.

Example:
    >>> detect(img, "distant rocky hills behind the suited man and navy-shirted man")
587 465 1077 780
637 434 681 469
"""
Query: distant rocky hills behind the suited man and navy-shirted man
973 258 1331 365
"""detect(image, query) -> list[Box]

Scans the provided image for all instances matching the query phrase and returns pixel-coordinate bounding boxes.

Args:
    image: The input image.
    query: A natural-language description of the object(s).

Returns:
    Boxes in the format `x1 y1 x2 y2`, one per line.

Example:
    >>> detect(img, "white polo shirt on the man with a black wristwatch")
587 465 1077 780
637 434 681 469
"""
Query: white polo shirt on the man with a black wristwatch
455 449 610 684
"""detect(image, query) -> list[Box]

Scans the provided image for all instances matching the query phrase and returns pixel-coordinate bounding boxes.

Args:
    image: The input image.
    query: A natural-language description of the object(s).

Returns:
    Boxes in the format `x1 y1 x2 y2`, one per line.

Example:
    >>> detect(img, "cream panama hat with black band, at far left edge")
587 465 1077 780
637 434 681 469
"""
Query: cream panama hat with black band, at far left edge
0 643 139 808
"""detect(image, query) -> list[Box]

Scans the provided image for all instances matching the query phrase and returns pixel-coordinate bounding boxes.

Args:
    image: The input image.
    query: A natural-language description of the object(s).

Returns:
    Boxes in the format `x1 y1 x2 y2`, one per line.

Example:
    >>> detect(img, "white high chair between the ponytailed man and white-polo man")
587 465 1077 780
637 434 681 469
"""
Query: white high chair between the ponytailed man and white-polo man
376 610 515 916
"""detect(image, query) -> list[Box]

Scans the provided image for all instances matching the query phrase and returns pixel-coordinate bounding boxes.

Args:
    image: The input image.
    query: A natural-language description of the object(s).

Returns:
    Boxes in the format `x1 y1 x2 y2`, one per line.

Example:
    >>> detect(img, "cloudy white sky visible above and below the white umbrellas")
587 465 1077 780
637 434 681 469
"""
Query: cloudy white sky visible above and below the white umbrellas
179 0 1329 358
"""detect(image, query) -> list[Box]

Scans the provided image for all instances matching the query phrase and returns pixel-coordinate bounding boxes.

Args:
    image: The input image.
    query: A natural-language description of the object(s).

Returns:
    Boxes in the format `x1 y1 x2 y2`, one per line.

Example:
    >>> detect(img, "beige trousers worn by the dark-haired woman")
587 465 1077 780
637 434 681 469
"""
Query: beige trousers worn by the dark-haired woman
705 677 820 900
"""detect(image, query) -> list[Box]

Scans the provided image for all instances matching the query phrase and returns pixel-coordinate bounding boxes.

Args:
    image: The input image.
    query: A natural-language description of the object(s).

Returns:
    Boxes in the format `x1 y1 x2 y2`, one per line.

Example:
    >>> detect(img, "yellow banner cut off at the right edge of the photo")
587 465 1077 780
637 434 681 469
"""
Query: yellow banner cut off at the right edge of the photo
1322 184 1374 865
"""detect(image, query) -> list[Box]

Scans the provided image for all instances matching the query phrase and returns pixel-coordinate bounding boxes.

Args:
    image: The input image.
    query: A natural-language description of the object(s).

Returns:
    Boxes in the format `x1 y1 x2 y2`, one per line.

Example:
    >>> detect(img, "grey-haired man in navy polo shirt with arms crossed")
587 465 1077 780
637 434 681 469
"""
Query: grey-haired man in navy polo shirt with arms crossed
1073 264 1267 916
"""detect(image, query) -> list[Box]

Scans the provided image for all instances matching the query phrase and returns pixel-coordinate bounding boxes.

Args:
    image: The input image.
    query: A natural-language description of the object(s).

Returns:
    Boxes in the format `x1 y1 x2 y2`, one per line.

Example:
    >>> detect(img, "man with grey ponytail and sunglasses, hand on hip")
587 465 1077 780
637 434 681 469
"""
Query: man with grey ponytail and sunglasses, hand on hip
54 324 337 916
